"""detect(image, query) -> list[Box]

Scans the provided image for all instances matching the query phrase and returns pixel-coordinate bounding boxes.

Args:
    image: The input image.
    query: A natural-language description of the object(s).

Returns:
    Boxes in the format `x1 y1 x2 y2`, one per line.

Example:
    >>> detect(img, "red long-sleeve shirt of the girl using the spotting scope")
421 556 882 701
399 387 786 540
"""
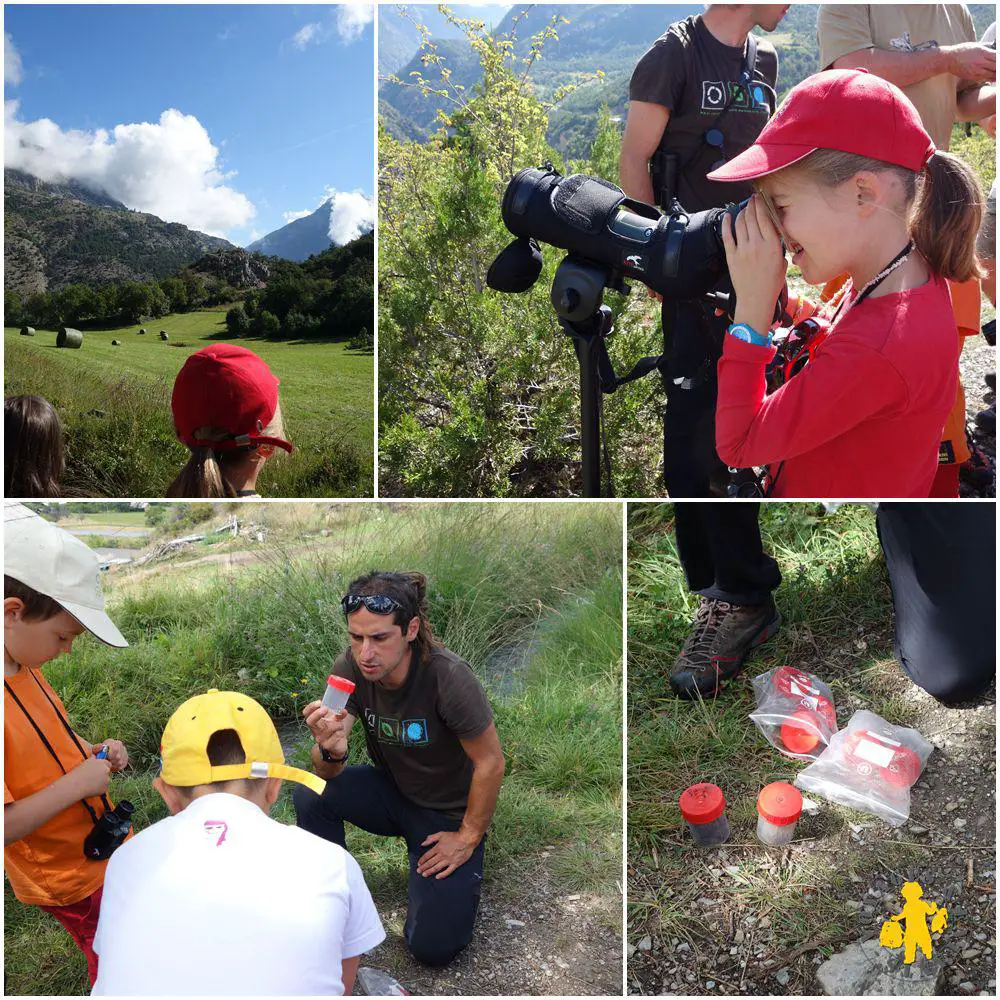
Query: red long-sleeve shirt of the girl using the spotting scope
716 275 961 500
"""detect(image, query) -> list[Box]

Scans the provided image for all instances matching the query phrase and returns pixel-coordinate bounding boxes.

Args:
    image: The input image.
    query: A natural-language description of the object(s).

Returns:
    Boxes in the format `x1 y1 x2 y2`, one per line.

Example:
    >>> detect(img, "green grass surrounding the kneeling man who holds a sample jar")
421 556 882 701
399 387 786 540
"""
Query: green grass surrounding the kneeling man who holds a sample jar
4 504 622 995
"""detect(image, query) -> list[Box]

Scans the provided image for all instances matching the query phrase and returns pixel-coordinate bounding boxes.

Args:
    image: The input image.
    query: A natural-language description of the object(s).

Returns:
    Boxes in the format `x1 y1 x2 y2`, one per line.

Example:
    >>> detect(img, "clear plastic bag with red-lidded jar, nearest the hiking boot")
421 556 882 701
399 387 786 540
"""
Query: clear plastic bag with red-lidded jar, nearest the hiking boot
750 667 837 760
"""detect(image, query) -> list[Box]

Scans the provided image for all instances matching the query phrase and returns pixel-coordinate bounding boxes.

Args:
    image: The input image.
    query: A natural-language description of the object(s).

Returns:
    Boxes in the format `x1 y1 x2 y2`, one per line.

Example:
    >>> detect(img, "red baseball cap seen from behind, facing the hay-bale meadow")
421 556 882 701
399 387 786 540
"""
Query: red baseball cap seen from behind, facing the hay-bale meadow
170 344 293 451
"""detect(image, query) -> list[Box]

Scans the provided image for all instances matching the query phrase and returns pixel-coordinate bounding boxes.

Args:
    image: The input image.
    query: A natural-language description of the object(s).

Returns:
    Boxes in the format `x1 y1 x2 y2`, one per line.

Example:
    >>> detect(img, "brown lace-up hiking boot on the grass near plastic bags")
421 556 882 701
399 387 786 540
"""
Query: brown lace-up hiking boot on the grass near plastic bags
670 596 781 699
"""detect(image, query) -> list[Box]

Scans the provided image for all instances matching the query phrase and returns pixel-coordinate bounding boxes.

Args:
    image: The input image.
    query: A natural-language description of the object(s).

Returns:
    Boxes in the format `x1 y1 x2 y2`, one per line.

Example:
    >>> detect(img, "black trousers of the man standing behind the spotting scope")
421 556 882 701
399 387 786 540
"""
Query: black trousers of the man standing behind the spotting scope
662 302 725 498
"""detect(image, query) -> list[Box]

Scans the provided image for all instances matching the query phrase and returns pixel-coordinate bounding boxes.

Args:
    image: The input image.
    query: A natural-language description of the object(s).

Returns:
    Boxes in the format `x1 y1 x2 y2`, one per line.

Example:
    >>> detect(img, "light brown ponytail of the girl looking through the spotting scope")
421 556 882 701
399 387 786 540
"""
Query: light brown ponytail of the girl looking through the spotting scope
909 150 984 281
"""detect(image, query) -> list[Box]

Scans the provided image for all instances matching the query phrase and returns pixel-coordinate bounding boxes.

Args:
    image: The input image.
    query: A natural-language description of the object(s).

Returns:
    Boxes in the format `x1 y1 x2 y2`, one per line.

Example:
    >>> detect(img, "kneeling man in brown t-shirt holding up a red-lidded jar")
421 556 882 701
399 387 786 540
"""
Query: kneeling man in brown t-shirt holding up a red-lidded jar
293 572 504 965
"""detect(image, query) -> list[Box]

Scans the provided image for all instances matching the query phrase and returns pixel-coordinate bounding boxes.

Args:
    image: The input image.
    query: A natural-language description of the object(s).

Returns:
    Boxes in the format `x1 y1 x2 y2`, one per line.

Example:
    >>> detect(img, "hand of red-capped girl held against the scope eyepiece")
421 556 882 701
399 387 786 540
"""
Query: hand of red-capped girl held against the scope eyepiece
722 195 788 333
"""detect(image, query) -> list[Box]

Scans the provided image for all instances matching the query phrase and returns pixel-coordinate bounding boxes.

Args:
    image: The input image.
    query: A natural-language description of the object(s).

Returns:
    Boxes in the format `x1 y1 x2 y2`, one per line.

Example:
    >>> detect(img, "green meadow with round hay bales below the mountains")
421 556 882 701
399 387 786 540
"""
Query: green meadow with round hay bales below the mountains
4 308 374 497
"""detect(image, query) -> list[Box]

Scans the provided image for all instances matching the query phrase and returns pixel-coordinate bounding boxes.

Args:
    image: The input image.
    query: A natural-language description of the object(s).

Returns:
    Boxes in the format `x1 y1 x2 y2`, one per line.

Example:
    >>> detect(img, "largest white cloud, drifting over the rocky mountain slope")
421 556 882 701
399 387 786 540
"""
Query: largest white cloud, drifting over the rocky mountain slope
4 101 256 235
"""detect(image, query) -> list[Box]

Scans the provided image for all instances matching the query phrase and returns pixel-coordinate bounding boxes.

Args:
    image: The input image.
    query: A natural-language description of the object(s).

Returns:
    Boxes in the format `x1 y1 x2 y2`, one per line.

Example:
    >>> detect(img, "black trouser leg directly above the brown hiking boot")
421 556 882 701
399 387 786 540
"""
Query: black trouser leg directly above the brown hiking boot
674 501 781 605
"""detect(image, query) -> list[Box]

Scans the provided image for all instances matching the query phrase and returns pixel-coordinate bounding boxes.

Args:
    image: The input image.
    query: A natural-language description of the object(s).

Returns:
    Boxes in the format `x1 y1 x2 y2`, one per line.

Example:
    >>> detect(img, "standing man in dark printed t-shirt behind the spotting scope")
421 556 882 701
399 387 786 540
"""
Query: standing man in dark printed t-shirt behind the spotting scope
618 4 789 499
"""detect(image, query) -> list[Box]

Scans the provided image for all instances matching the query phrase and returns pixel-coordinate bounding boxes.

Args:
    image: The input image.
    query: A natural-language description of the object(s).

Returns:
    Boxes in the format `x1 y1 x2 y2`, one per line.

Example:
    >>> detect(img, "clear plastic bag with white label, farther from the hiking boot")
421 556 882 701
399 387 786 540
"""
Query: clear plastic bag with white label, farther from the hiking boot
795 709 934 826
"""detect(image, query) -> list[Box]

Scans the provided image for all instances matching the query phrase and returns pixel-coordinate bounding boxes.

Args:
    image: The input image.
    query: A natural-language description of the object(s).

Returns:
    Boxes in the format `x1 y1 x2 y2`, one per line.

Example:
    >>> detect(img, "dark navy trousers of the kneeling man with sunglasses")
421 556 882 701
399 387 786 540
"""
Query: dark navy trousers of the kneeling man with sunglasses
292 765 485 965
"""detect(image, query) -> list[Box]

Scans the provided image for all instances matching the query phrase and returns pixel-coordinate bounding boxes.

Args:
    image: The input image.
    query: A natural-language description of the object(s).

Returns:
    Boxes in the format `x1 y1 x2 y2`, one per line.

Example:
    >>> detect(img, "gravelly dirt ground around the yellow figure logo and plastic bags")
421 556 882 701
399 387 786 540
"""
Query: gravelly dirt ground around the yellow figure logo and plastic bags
627 616 996 996
